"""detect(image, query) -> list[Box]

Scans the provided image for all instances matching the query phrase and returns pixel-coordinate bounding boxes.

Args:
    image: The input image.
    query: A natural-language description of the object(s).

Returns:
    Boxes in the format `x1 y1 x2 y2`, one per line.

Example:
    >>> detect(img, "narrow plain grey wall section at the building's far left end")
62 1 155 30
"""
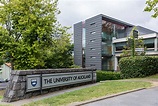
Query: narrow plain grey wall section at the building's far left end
74 22 82 67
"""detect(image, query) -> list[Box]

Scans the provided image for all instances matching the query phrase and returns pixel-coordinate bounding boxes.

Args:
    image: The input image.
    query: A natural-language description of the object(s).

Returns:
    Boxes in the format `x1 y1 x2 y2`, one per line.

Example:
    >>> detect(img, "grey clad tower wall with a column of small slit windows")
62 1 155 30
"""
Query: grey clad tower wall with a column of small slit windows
85 15 102 70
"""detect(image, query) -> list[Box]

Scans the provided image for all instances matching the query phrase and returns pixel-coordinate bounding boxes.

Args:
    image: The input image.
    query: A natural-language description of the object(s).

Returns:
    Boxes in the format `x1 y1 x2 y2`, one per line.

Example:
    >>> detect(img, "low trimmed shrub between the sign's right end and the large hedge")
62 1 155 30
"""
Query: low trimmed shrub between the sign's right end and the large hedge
97 70 122 82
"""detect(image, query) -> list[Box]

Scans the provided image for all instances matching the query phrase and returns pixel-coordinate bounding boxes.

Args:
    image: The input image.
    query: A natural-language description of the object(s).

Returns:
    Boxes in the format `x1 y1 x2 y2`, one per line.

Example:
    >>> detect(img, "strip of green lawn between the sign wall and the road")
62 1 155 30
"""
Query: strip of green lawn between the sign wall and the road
25 81 151 106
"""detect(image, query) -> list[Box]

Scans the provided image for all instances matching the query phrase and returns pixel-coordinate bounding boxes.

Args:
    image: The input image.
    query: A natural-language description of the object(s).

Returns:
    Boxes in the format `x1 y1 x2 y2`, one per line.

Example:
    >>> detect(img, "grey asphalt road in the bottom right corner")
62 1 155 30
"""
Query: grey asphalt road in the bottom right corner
84 87 158 106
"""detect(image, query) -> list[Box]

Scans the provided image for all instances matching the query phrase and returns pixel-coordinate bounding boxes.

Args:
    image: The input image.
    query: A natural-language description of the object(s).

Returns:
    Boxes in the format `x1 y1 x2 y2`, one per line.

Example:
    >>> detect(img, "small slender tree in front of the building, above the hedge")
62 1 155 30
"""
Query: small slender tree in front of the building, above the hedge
121 27 145 57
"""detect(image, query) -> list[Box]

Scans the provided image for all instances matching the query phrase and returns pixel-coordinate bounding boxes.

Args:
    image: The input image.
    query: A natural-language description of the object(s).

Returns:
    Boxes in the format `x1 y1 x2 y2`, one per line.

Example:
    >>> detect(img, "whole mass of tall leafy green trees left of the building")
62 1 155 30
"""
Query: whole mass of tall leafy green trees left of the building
0 0 72 69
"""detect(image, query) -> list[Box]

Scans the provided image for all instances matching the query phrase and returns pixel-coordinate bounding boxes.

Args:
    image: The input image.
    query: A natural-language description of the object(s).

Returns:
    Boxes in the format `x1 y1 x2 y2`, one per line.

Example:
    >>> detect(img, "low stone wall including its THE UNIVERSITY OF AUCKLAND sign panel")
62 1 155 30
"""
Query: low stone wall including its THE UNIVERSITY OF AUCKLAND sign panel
2 68 96 102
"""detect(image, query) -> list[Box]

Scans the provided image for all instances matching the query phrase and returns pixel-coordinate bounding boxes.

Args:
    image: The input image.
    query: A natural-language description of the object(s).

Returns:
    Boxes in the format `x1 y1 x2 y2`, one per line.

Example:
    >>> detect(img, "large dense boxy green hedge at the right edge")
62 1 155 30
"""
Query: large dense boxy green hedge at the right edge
119 56 158 78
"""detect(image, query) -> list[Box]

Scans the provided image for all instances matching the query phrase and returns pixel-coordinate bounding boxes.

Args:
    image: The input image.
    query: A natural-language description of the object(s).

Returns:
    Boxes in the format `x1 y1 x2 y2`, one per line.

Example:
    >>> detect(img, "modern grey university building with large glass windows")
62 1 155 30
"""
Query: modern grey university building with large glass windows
74 14 158 70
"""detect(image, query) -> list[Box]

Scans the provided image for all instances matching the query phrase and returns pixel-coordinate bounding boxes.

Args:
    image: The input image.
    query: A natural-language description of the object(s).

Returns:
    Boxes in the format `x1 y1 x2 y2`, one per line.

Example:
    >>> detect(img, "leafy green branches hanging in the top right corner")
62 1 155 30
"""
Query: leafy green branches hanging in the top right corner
144 0 158 18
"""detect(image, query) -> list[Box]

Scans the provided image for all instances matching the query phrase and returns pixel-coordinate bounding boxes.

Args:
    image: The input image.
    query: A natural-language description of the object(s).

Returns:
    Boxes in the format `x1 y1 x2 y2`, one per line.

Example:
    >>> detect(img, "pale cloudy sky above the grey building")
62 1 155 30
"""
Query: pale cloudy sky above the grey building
57 0 158 36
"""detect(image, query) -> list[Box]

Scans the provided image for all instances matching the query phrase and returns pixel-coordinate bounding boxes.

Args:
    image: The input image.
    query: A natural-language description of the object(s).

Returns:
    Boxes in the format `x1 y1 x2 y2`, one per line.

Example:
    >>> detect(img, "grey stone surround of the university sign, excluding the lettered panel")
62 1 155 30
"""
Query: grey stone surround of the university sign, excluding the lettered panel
2 68 96 102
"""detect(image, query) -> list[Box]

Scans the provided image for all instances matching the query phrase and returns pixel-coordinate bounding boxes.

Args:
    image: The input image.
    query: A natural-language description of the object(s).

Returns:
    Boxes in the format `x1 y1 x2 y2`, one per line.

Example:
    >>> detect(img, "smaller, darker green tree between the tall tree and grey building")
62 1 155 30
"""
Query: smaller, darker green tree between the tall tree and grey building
45 26 73 68
